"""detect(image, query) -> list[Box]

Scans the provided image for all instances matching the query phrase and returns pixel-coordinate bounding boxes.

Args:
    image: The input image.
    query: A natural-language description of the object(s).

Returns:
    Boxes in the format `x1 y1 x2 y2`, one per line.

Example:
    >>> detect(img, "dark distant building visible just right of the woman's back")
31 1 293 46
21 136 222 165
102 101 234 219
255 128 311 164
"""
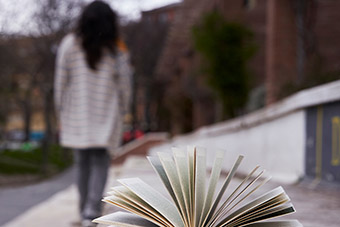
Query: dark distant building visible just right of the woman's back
123 3 180 131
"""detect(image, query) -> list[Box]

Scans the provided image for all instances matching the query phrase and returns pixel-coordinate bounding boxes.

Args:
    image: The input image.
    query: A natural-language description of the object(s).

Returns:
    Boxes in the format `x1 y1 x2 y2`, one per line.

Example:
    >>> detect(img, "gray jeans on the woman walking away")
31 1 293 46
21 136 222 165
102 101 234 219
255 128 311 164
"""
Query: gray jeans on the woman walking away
75 148 110 219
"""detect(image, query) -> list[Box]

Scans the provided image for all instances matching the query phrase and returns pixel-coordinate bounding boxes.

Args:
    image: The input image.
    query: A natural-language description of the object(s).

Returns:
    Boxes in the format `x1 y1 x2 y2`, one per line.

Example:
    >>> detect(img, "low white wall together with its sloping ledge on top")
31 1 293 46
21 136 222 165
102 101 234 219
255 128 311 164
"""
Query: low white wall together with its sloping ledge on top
149 80 340 183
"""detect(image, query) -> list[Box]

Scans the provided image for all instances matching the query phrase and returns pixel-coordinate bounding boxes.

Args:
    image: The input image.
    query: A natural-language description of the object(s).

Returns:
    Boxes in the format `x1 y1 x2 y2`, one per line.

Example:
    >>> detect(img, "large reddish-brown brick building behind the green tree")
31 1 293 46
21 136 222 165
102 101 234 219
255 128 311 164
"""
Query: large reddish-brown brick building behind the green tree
157 0 340 133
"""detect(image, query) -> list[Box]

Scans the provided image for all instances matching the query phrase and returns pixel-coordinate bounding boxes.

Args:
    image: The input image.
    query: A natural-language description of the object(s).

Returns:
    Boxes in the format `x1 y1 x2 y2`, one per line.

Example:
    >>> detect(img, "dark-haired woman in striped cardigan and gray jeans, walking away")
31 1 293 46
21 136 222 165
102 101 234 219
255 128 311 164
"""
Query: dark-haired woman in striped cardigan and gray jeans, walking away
54 1 131 226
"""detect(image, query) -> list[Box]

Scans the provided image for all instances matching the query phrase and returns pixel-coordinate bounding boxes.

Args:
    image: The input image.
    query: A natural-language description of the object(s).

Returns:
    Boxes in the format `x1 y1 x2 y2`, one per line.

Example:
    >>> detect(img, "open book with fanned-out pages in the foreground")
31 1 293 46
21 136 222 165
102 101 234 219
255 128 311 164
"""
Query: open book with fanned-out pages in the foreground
94 148 302 227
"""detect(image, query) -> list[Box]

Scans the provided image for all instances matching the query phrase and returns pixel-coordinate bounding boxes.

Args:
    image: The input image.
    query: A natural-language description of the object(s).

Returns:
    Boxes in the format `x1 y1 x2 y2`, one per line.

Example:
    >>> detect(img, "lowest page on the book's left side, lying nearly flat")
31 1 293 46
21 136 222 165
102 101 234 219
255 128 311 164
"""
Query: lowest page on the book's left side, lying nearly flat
93 211 157 227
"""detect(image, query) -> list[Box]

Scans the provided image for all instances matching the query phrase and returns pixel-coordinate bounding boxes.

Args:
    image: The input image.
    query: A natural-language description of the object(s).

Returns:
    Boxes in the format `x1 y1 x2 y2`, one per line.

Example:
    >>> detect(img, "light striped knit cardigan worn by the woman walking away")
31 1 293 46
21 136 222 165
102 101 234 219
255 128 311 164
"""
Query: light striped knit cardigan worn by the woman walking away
54 34 132 154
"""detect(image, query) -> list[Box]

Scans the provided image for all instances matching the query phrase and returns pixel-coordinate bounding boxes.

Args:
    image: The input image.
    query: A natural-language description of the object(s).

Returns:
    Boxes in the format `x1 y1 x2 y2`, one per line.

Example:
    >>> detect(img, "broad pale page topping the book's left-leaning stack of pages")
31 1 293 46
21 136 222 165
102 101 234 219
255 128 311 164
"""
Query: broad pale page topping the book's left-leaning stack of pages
118 178 184 227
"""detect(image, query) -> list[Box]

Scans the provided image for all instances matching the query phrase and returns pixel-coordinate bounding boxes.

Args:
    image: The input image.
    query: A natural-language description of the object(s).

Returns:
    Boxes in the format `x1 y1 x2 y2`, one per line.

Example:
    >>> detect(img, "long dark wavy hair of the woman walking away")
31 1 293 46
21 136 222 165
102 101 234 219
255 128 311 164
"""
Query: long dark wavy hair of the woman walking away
76 1 118 70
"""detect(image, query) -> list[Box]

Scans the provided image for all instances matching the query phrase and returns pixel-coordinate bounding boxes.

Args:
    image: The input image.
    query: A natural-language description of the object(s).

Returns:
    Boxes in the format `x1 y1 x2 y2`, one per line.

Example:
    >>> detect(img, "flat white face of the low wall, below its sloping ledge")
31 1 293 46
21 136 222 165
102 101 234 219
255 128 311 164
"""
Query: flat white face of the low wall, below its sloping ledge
150 110 305 183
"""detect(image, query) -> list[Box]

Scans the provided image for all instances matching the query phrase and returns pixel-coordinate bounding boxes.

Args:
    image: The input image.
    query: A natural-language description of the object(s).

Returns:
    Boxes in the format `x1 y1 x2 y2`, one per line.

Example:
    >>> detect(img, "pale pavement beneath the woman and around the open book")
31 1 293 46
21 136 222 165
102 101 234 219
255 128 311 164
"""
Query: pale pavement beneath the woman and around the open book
3 157 340 227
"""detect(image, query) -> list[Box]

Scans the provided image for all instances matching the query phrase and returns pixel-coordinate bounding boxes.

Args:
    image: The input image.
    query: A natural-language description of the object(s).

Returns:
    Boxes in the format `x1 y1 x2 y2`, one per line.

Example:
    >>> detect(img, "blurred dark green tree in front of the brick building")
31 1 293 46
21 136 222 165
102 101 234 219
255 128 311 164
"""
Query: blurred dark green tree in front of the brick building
192 12 256 118
